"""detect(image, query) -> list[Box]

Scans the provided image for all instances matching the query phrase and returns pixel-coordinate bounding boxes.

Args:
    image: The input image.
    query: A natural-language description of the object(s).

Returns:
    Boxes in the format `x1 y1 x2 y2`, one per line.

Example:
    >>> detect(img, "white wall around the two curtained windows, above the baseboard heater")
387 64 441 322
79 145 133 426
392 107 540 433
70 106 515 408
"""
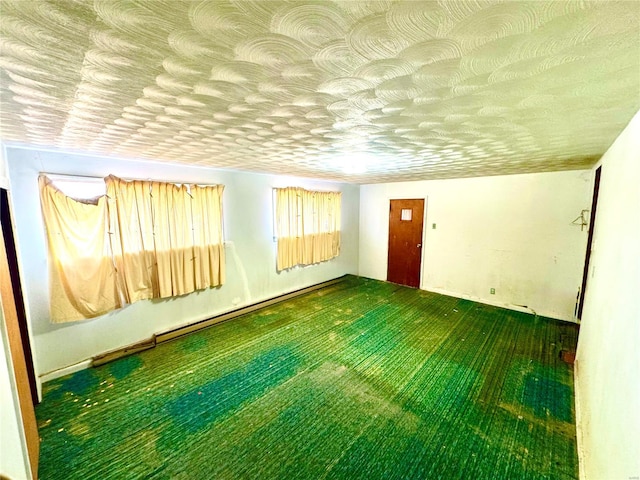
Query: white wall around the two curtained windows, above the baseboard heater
6 146 359 376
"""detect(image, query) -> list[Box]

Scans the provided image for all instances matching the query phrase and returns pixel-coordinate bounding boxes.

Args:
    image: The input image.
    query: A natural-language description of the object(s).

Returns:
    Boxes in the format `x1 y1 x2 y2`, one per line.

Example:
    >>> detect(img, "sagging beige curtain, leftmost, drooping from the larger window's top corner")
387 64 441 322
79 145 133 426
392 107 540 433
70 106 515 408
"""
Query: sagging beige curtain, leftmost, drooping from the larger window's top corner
38 176 122 323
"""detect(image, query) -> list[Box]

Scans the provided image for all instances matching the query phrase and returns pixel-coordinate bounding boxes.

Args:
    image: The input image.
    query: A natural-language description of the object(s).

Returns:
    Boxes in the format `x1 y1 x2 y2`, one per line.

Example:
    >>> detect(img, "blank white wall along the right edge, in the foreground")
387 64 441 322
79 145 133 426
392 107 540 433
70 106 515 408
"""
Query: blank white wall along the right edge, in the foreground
576 113 640 480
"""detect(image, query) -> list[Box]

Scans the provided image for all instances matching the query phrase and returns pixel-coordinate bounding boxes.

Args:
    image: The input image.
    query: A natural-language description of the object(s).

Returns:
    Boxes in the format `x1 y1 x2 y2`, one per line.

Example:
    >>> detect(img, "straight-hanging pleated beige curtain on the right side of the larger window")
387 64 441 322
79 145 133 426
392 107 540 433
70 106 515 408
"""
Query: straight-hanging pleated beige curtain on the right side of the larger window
106 176 225 302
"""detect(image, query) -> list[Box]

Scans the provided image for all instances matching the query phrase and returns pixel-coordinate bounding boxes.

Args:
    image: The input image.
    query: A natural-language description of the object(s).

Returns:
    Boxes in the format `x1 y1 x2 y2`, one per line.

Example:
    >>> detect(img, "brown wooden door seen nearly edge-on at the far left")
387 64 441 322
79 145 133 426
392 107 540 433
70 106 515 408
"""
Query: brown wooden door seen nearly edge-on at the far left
0 213 40 479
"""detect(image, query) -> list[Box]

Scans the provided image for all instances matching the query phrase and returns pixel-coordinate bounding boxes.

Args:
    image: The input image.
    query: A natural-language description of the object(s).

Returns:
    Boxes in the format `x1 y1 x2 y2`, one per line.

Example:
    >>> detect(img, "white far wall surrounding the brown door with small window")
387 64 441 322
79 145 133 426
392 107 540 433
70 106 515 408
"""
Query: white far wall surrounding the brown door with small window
360 171 592 320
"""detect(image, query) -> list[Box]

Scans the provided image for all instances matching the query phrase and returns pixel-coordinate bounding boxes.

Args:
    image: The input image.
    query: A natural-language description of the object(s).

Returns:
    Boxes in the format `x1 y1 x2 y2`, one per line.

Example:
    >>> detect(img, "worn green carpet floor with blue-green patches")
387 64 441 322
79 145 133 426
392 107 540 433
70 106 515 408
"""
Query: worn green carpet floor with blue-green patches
36 277 578 480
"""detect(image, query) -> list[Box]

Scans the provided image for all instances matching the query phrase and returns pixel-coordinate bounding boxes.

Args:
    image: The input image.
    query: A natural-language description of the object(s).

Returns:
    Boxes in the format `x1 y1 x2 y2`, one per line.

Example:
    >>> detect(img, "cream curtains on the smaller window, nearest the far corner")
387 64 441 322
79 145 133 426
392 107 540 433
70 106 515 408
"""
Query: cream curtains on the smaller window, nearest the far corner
275 187 342 271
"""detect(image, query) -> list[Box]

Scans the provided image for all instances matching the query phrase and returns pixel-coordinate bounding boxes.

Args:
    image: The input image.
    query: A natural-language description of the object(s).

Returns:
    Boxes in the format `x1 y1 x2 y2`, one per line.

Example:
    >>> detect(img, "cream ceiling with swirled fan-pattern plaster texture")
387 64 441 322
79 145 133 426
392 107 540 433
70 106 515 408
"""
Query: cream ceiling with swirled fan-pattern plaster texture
0 0 640 183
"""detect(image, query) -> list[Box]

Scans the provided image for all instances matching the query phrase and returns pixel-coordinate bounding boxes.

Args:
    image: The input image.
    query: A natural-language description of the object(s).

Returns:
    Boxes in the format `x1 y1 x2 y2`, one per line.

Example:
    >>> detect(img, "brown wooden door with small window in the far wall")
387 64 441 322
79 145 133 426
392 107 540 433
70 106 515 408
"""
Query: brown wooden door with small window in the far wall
387 199 424 288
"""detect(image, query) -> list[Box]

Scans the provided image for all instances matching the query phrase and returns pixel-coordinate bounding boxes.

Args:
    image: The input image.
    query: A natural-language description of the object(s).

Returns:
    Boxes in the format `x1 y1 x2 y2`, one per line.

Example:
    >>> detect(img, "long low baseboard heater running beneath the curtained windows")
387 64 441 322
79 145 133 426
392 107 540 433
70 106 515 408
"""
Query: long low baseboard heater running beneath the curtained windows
91 275 347 367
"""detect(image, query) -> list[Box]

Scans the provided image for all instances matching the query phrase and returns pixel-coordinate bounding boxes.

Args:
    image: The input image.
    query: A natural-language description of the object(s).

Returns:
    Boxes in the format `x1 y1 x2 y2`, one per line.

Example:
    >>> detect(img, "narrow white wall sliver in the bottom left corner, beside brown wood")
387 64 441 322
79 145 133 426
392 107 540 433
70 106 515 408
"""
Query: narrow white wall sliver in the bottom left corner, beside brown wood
0 305 31 480
